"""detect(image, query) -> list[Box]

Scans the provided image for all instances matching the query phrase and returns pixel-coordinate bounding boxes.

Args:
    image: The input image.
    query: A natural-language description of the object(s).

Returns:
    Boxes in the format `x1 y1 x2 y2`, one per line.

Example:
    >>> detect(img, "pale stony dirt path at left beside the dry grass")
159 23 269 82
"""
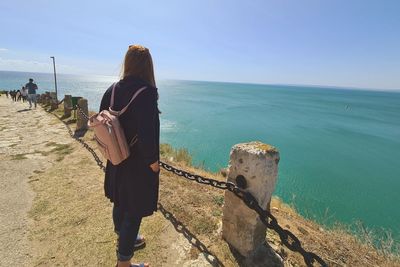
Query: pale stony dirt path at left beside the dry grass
0 96 71 266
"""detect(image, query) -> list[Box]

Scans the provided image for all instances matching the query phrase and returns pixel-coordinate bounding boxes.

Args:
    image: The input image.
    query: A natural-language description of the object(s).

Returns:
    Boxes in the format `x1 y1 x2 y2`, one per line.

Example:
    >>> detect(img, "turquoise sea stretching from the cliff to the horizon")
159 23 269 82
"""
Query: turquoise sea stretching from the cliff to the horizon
0 71 400 242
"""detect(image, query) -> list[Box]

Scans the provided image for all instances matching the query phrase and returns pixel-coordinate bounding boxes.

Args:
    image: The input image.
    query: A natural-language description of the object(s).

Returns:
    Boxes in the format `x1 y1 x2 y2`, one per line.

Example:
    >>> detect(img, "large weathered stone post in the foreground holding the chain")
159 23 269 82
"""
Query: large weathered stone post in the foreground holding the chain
222 142 279 257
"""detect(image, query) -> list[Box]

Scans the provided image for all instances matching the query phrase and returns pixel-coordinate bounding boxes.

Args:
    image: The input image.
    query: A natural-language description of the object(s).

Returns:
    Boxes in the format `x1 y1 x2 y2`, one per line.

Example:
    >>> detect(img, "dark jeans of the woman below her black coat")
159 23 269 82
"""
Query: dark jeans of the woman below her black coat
113 205 142 261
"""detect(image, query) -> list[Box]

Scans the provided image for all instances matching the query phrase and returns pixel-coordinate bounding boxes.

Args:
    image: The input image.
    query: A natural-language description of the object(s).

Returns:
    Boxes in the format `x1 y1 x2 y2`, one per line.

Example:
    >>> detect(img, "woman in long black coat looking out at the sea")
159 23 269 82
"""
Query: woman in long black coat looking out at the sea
100 45 160 267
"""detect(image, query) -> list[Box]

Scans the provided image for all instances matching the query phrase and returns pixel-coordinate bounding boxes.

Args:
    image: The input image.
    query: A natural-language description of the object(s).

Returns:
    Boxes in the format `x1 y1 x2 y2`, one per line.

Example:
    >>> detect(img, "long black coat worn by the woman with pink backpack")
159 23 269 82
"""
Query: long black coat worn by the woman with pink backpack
100 77 160 217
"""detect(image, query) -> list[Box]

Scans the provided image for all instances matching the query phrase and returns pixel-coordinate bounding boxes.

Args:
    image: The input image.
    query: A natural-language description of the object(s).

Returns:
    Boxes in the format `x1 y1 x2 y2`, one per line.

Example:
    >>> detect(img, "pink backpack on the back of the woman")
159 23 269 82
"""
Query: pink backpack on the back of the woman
88 83 146 165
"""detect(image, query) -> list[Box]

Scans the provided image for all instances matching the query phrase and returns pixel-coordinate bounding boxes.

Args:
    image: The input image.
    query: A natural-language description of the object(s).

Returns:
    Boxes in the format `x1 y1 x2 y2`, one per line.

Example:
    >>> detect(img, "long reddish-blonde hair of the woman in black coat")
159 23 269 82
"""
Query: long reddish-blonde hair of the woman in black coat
121 45 156 87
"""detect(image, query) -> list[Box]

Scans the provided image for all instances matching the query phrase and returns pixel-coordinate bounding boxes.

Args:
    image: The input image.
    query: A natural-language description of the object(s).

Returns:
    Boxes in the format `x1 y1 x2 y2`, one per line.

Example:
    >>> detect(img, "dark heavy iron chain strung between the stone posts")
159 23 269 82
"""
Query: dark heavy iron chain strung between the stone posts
64 105 328 266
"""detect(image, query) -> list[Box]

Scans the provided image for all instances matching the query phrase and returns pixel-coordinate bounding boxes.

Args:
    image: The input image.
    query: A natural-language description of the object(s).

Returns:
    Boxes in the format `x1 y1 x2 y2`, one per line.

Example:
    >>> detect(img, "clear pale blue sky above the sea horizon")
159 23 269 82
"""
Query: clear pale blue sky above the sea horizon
0 0 400 89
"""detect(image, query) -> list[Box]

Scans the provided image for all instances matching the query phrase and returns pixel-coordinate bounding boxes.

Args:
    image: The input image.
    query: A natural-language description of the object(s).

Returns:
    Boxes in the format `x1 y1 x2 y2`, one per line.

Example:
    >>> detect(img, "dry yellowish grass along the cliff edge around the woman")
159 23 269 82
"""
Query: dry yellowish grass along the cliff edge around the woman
25 102 400 266
